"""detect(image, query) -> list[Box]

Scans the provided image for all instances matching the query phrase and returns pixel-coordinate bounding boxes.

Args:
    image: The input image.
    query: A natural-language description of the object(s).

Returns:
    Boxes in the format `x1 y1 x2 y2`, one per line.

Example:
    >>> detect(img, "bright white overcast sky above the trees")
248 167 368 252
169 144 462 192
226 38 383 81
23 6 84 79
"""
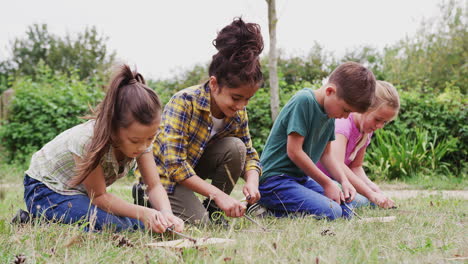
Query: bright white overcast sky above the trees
0 0 440 79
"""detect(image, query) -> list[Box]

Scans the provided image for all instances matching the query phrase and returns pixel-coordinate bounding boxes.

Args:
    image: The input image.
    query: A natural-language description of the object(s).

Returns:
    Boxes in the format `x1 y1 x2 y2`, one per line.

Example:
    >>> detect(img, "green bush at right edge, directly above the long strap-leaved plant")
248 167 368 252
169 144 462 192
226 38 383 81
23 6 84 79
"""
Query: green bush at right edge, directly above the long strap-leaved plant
384 84 468 175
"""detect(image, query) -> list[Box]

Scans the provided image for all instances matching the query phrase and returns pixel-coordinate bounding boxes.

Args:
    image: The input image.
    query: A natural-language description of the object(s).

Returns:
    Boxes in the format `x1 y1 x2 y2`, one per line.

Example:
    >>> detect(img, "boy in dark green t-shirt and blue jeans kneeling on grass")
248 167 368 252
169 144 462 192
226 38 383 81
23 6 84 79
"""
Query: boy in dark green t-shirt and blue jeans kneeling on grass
259 62 375 220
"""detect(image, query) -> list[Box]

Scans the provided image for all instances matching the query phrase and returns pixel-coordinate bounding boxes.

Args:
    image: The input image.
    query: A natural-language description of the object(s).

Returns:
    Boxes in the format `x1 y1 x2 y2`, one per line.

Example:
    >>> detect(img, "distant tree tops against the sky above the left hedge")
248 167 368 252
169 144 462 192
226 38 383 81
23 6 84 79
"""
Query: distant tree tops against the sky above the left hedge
4 24 115 80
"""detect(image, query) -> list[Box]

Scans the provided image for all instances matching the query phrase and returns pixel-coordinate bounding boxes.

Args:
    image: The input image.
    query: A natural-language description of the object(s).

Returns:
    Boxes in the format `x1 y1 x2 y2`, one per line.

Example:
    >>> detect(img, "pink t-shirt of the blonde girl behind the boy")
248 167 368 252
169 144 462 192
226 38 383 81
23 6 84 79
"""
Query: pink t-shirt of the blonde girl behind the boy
317 114 372 177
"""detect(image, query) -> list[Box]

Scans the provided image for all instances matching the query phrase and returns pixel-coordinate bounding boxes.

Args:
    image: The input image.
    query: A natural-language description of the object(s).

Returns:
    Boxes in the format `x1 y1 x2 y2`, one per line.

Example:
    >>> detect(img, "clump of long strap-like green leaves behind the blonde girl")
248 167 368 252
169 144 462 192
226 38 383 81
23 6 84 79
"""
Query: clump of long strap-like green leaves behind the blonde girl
365 128 456 179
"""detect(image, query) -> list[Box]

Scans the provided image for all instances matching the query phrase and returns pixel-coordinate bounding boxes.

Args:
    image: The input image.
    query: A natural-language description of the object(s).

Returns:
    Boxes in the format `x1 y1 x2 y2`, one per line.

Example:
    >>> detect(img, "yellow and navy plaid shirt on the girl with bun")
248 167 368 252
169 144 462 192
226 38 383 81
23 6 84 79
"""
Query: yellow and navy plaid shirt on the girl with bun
153 85 262 193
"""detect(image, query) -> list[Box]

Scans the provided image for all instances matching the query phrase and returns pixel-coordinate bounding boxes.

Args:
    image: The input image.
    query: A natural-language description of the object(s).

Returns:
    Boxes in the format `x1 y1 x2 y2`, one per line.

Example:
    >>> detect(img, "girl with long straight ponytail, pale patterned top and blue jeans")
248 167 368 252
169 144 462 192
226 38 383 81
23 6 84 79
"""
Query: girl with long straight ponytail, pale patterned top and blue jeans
24 65 183 233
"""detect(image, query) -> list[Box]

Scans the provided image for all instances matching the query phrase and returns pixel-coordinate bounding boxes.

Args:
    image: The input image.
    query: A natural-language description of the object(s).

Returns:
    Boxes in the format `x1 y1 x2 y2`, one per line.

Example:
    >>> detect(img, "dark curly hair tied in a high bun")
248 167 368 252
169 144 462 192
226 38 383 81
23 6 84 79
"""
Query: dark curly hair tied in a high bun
208 18 263 88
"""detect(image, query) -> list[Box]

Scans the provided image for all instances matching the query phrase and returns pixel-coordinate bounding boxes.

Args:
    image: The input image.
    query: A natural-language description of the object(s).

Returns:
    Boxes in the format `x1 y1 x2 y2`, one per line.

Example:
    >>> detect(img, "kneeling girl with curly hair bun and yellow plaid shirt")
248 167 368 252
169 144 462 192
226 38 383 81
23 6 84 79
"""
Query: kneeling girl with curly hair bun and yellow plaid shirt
135 18 263 223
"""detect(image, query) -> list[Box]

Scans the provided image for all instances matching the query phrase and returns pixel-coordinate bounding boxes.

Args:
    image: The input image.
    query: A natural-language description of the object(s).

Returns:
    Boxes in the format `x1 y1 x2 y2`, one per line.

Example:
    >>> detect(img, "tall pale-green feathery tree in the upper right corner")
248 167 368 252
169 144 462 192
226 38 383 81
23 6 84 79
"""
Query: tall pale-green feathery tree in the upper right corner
383 0 468 95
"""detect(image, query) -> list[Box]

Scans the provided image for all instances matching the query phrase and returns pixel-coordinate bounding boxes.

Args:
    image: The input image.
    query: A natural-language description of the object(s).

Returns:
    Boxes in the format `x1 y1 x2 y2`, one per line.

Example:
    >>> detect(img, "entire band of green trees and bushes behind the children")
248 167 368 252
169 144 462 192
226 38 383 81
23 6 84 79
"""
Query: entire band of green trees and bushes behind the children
0 1 468 179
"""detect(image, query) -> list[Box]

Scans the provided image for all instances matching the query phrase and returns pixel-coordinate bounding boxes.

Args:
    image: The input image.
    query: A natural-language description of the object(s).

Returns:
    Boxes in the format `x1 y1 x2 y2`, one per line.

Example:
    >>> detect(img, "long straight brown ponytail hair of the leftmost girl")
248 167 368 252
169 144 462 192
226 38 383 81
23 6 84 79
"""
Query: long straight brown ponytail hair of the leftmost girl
70 65 161 186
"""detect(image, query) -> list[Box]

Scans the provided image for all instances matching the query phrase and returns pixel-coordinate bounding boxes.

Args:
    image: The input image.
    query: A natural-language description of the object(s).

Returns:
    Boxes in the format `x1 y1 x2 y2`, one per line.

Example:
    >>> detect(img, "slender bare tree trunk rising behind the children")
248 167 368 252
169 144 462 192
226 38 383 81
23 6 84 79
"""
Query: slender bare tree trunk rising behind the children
266 0 279 121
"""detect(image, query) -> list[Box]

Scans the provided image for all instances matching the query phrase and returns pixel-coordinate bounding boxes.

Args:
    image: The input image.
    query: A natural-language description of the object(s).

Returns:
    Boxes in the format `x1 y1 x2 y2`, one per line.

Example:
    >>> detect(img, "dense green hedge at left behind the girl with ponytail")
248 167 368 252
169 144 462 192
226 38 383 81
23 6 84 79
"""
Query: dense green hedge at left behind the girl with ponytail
0 66 103 161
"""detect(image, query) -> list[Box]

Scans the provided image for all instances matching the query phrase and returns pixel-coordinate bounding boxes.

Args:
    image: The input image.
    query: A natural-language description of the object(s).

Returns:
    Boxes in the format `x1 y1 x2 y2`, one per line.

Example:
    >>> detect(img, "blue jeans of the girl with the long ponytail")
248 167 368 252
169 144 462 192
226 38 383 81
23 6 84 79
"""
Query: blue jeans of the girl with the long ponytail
24 175 144 232
